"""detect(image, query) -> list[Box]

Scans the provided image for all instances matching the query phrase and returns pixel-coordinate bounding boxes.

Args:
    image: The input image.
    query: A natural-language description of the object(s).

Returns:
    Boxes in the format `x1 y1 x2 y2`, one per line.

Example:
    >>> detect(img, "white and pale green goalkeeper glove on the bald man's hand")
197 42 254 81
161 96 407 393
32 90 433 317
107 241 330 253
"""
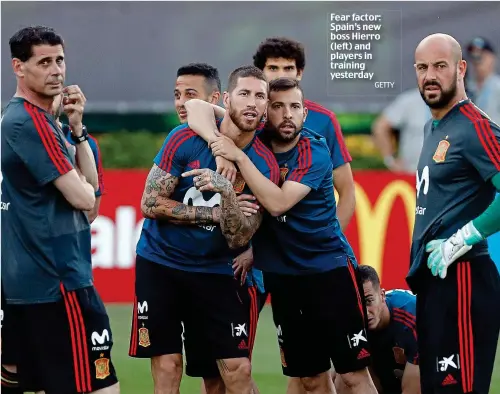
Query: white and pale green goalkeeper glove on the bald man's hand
425 221 484 279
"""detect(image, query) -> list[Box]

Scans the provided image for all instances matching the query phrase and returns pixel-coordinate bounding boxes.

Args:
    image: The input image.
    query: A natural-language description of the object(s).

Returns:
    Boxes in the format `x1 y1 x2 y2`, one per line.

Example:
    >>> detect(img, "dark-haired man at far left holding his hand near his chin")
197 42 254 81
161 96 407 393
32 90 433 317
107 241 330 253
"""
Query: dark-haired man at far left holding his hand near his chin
1 26 119 394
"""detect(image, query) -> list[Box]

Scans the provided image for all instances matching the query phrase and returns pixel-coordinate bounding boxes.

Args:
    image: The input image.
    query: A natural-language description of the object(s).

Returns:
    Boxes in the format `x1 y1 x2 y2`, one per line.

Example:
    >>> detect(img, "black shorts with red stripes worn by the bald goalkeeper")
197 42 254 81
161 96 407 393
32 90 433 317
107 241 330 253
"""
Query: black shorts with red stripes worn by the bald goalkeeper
417 256 500 394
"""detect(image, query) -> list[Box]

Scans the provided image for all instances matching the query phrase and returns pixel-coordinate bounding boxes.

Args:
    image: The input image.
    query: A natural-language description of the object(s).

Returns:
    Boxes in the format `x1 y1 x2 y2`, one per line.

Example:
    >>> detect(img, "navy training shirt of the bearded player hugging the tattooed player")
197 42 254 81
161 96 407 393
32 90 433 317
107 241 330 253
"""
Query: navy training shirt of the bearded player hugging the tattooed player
252 129 354 275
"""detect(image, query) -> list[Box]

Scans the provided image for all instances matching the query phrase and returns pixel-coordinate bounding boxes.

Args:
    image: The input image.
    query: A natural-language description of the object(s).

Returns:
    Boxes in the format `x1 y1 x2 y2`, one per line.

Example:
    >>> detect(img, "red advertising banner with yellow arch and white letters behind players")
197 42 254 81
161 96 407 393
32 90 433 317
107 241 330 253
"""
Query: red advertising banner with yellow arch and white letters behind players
92 170 415 302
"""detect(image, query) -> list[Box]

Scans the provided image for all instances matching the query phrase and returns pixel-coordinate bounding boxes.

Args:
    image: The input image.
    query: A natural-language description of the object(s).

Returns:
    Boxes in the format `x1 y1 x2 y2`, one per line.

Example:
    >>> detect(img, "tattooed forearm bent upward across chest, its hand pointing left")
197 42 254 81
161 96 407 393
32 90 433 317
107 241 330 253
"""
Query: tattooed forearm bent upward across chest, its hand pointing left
183 169 262 249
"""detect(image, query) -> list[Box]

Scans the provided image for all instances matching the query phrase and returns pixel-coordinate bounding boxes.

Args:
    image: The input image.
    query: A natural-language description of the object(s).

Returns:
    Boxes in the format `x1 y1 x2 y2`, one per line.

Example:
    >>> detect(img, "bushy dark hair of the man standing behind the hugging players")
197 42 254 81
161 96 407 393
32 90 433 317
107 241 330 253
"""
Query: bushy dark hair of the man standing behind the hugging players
253 37 306 70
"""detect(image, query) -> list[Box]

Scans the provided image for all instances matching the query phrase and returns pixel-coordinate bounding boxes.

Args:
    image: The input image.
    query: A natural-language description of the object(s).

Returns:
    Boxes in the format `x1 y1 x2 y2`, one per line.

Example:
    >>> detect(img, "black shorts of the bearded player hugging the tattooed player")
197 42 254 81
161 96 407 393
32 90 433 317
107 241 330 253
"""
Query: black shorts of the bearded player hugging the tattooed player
264 262 371 377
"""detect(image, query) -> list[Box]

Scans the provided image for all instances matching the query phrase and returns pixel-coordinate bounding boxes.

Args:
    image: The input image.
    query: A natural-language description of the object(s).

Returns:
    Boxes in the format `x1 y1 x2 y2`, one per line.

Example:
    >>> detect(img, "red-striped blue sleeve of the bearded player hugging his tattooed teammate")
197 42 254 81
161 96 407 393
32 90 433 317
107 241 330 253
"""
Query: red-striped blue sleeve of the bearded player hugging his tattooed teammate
286 137 332 190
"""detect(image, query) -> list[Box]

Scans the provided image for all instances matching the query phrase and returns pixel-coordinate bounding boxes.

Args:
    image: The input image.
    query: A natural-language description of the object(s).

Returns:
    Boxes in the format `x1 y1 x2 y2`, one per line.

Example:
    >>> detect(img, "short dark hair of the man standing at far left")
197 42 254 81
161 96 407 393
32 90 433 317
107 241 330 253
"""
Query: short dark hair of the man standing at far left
9 26 64 62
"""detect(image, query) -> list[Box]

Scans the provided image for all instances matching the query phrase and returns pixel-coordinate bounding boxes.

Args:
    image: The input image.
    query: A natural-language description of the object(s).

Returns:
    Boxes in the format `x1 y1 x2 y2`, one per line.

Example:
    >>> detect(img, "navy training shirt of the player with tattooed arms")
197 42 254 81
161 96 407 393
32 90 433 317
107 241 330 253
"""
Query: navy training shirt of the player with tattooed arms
137 125 279 275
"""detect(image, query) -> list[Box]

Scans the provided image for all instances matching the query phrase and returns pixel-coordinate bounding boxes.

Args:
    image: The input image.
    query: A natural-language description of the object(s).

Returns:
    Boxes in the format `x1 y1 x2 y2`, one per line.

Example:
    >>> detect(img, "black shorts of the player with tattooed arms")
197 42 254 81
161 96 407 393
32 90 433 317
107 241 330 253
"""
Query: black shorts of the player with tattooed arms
129 256 257 372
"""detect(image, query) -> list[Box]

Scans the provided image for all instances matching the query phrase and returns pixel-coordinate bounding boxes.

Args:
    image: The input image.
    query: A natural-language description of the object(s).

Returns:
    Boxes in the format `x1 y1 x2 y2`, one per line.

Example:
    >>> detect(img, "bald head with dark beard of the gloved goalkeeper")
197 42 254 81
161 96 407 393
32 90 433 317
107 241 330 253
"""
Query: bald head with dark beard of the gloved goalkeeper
415 34 467 110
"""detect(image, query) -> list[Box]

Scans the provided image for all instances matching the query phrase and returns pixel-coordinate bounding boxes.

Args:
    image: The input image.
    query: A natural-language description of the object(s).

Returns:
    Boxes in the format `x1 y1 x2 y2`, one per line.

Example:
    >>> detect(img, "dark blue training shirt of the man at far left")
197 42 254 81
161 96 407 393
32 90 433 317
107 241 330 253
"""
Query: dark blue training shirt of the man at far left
1 97 92 304
